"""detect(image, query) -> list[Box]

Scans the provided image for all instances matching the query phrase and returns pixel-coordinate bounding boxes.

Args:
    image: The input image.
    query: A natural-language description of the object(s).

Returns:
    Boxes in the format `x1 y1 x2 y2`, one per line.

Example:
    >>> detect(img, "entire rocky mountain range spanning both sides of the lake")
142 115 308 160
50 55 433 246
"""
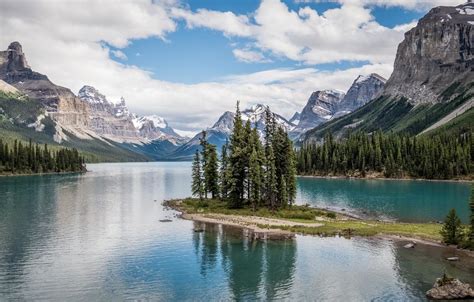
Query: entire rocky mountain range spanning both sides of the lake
0 3 474 161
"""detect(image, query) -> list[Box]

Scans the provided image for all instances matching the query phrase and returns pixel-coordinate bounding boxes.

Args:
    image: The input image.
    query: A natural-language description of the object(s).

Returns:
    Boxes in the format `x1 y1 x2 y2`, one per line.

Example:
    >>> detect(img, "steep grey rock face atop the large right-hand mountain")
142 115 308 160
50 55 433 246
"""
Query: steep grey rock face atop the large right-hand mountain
383 3 474 105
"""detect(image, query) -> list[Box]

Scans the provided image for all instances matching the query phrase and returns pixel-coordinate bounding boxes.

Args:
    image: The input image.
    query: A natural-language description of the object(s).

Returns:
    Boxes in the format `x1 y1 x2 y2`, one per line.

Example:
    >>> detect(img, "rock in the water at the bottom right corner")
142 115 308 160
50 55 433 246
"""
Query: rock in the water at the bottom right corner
426 275 474 300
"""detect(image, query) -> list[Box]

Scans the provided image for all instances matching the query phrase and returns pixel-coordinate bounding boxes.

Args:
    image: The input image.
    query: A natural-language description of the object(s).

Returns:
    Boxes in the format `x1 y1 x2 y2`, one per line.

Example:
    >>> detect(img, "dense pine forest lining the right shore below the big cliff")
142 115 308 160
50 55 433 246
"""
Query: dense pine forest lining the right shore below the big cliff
297 131 474 179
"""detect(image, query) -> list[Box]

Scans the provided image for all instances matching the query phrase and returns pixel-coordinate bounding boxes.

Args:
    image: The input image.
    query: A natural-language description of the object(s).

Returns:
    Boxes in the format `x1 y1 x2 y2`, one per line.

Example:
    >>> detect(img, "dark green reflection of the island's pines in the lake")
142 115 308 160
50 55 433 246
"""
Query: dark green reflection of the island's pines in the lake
193 222 296 300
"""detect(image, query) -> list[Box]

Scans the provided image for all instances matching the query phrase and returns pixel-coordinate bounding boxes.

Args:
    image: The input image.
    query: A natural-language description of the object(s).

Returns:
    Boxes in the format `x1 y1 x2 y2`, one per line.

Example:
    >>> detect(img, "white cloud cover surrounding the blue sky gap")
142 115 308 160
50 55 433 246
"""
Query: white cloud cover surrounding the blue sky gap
0 0 436 133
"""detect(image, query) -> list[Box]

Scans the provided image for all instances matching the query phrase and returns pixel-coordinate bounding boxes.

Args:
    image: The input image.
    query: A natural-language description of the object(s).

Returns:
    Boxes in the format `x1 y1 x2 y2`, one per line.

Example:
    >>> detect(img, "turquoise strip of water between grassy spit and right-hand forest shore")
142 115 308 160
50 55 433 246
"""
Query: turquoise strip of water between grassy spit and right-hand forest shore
297 178 471 223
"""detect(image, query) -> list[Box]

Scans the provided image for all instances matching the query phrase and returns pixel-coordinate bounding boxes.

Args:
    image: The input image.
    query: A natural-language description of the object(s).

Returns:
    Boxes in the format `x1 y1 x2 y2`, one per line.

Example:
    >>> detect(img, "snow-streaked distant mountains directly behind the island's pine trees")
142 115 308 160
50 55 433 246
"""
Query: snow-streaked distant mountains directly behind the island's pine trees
169 104 295 160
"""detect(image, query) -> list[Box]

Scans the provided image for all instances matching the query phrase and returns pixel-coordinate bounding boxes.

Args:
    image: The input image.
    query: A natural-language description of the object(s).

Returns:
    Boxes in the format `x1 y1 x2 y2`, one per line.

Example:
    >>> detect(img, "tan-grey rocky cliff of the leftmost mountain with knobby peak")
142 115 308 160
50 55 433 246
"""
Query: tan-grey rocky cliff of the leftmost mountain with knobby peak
0 42 89 127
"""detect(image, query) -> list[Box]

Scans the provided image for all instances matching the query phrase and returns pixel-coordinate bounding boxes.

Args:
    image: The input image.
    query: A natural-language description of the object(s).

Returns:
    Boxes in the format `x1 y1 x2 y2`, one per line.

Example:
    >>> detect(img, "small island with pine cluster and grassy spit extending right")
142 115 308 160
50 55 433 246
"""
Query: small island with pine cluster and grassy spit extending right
164 103 474 248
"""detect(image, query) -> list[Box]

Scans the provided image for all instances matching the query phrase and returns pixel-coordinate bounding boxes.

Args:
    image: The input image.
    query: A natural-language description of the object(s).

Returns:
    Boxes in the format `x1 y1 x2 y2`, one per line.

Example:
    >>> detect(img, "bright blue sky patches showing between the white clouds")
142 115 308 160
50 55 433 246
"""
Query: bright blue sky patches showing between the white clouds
109 0 426 84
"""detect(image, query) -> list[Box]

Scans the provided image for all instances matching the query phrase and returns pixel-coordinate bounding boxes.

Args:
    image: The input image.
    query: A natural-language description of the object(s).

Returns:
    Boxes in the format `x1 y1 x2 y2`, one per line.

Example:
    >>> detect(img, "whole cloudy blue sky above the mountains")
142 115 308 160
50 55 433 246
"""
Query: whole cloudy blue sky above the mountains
0 0 465 135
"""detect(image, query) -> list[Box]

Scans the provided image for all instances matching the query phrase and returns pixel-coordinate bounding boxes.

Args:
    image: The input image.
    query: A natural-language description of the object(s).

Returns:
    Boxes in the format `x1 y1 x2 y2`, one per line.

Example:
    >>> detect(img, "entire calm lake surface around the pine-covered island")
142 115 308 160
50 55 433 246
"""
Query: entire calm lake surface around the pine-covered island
0 163 474 301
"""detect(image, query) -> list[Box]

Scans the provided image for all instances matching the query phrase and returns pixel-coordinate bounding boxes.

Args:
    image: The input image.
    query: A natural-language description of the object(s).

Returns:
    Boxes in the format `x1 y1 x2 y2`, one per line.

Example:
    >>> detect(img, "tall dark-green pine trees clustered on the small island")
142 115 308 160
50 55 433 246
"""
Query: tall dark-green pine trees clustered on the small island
192 103 296 210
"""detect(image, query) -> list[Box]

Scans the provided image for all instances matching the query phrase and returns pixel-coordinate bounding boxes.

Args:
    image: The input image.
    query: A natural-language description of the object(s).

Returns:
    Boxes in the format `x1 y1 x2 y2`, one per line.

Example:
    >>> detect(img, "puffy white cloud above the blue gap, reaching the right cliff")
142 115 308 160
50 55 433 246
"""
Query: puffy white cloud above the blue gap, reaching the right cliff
174 0 416 64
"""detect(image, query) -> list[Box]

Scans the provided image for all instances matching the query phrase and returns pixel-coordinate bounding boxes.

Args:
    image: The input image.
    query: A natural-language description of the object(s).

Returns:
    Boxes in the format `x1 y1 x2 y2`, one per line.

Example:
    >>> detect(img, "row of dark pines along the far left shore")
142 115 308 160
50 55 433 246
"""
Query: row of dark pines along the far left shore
0 139 85 174
